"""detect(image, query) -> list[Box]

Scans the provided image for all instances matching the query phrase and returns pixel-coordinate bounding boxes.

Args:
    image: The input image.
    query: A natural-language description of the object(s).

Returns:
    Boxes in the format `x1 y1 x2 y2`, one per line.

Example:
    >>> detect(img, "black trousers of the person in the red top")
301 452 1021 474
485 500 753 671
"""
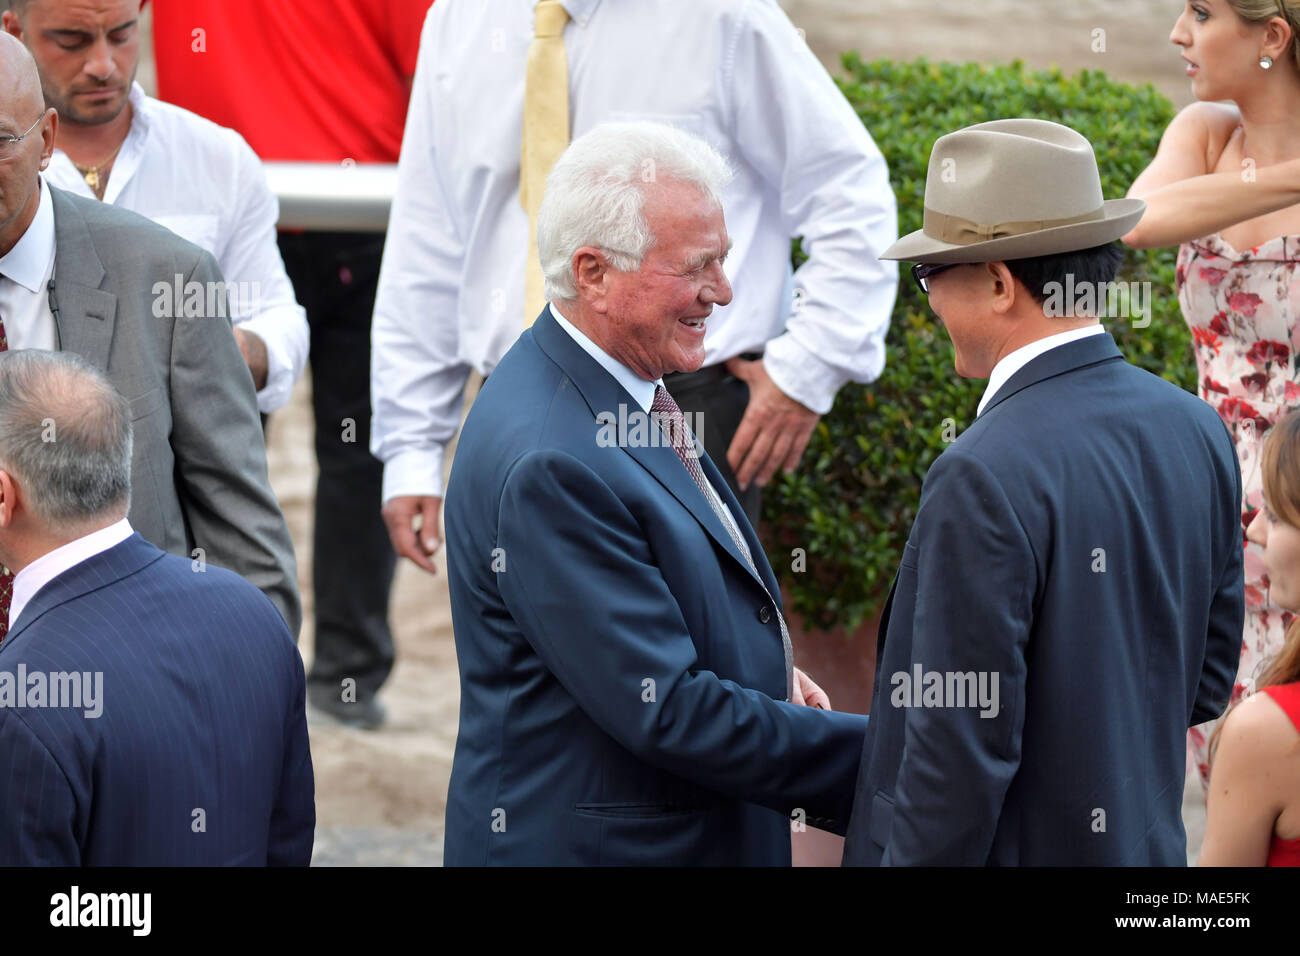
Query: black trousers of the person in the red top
280 233 397 701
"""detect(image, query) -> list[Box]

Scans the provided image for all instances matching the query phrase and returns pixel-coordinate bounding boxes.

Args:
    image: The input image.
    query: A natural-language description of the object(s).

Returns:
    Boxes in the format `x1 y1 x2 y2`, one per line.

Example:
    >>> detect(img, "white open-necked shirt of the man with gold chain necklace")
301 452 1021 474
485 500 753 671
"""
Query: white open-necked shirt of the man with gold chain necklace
46 83 309 412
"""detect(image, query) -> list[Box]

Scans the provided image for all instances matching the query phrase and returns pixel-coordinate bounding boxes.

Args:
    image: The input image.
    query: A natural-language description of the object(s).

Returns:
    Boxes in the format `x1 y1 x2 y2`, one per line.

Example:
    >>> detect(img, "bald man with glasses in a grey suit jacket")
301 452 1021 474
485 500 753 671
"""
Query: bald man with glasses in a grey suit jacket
0 34 302 635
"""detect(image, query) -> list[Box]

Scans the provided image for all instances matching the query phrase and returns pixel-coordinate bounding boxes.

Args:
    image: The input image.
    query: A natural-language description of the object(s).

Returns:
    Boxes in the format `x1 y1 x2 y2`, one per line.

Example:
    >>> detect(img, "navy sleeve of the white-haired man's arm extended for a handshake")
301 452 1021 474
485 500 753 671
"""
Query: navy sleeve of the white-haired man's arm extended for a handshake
498 451 866 830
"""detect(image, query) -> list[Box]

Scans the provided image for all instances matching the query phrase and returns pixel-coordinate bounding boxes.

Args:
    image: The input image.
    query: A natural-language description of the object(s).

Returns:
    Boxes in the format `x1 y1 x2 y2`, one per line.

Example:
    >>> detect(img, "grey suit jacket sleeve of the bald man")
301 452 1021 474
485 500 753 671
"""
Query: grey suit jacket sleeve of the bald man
170 252 303 640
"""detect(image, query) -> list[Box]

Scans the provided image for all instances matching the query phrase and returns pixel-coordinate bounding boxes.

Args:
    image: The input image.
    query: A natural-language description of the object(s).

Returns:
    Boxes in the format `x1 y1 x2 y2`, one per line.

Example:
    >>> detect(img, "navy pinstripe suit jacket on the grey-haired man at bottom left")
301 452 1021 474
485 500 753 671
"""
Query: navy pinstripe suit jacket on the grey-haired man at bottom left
0 535 316 866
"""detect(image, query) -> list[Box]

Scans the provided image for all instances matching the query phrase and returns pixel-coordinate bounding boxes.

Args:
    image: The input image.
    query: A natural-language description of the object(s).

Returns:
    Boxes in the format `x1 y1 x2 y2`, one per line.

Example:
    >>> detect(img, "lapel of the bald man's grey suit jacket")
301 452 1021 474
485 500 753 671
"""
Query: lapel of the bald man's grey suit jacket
49 187 117 369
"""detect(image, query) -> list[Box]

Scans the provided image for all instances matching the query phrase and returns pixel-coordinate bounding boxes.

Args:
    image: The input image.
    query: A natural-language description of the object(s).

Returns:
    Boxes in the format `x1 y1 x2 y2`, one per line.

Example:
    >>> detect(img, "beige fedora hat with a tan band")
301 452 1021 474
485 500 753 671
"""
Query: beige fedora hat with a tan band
880 120 1147 263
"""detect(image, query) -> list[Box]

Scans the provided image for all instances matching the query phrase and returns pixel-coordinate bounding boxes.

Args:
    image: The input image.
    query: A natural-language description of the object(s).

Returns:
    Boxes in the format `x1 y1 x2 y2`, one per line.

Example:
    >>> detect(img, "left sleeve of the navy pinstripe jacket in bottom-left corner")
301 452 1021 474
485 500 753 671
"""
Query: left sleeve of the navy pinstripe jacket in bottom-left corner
0 710 81 866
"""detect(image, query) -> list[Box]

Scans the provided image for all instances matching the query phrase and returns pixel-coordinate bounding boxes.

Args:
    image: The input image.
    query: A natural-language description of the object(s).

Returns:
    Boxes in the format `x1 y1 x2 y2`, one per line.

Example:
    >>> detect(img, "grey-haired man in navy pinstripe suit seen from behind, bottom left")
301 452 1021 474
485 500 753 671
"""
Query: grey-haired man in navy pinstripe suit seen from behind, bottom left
0 349 316 866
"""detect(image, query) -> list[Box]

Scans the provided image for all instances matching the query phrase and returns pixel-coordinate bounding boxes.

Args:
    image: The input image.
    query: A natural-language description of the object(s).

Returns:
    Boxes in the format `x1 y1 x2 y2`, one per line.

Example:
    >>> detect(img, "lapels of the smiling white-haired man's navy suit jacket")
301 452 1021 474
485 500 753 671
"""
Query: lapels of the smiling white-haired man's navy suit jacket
525 308 775 593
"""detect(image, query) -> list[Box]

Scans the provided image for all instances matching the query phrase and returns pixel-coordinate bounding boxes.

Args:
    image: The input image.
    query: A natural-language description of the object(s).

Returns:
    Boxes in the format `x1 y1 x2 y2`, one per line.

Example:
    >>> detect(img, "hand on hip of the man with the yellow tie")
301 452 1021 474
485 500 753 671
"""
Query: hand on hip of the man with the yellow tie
727 358 820 490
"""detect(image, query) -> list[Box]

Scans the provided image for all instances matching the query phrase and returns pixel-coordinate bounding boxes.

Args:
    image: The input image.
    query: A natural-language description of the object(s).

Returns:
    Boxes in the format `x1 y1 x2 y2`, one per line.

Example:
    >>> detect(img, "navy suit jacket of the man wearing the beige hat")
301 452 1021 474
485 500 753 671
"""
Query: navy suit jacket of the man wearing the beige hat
844 334 1244 865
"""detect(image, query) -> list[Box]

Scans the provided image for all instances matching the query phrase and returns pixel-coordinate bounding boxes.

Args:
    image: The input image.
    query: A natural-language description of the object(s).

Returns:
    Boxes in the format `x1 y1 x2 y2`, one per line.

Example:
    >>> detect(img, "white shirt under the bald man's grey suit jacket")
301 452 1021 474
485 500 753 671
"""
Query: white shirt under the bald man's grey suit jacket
0 175 59 351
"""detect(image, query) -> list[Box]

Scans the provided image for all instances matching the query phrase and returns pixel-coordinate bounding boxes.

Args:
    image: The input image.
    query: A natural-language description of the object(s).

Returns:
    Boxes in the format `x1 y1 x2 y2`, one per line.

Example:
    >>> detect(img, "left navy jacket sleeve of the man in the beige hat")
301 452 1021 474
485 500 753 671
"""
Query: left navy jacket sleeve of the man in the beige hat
874 449 1036 865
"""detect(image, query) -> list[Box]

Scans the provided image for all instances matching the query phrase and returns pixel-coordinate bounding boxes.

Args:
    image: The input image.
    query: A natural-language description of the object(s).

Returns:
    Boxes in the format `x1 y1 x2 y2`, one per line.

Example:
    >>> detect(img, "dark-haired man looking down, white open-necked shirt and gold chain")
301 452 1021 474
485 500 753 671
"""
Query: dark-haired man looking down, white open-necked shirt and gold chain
4 0 308 414
